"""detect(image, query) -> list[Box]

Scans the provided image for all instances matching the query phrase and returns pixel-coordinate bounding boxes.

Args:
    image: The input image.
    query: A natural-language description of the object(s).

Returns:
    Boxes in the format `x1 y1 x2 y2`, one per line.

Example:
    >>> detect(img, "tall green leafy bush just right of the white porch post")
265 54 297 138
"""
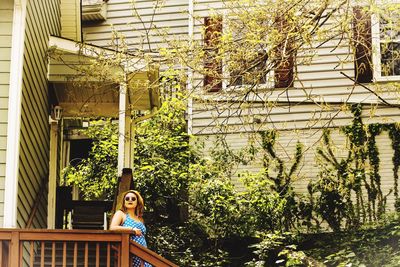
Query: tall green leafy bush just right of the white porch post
133 95 196 223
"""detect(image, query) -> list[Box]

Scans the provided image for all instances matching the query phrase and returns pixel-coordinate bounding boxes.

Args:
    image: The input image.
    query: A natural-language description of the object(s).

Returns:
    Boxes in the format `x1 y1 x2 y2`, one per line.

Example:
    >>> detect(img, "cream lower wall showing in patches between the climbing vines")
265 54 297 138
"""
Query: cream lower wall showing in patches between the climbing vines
200 129 400 210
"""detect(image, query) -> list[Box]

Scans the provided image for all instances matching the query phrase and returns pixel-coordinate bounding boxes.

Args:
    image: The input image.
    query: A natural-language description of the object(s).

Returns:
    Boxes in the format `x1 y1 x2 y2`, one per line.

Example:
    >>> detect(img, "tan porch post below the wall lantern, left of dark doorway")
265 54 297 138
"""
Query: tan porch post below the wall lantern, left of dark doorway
47 120 58 229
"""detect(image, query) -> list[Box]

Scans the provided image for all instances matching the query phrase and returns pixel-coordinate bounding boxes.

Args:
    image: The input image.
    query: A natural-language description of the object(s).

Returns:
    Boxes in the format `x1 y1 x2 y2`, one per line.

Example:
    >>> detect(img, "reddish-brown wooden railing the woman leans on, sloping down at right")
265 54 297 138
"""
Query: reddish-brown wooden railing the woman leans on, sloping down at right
0 229 177 267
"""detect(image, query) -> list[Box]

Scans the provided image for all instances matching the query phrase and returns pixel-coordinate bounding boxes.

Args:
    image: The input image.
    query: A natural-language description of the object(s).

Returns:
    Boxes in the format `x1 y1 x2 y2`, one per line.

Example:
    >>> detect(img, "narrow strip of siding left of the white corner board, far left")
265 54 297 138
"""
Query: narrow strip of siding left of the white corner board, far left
0 0 14 227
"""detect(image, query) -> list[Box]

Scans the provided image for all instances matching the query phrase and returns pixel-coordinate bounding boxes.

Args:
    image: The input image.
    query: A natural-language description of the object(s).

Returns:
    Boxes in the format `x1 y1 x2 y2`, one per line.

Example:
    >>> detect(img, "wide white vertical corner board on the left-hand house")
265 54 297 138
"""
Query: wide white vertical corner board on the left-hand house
3 0 27 228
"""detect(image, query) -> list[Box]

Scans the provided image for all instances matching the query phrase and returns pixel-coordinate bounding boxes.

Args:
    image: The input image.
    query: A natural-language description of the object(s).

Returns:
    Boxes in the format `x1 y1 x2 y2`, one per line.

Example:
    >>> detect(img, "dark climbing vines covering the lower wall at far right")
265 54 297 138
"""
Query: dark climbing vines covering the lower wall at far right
309 104 400 230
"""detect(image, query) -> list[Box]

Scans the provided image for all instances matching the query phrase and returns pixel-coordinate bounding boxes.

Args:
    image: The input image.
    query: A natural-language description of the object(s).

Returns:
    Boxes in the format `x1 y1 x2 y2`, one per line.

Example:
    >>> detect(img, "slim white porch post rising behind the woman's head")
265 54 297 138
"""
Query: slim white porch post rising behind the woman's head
118 79 129 175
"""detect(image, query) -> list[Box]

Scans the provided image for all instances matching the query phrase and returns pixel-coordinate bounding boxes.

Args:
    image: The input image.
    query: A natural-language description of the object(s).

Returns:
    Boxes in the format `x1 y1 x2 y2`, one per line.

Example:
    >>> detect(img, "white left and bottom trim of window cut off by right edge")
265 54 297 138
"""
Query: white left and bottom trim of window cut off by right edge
371 5 400 82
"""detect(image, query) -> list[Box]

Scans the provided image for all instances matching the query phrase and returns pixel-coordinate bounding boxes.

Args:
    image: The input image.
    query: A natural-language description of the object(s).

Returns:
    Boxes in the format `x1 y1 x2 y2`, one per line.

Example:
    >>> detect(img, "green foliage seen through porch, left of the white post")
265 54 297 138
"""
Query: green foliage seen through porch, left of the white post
61 120 118 200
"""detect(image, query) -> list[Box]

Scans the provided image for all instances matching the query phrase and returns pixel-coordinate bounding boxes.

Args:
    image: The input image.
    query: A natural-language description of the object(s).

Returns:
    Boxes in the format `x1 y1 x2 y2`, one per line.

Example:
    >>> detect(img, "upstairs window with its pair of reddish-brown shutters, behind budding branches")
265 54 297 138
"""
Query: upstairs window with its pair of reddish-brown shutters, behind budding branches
203 14 294 92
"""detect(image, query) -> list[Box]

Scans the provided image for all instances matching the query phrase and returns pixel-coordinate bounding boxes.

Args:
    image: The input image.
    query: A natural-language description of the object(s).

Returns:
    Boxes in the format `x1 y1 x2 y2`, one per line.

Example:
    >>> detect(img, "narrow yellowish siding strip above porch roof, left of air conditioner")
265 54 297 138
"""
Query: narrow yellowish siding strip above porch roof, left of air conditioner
60 0 81 41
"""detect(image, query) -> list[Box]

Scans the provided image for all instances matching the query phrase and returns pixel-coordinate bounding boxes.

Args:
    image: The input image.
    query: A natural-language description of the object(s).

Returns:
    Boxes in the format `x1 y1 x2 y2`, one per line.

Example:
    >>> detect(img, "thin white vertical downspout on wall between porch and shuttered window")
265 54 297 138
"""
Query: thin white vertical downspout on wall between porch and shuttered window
187 0 194 134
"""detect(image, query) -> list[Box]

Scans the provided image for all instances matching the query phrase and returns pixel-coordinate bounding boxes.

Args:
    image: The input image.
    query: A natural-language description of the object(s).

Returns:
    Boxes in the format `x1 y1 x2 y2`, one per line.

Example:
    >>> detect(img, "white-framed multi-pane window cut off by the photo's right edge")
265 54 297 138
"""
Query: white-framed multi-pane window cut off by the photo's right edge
372 4 400 80
